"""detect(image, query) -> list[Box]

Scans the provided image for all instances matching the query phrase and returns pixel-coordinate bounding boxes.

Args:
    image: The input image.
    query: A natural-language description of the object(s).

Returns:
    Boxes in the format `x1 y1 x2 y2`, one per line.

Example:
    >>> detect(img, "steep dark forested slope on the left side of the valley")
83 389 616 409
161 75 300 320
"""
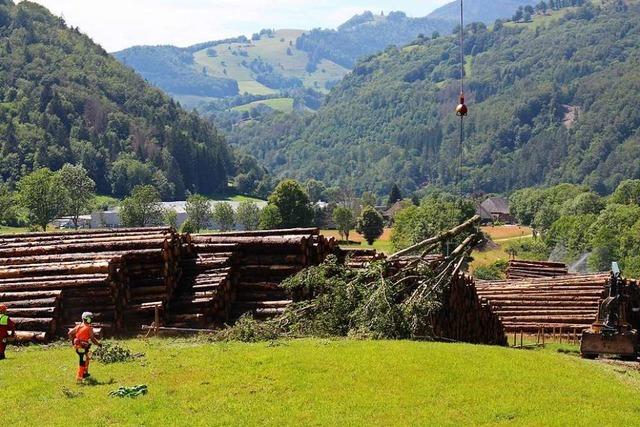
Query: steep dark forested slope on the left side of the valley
0 0 232 198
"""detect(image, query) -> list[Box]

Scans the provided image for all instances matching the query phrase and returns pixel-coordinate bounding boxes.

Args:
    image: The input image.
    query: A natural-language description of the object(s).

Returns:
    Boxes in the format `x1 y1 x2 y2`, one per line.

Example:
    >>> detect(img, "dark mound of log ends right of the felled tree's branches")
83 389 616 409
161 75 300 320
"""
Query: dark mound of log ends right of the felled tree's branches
431 274 507 345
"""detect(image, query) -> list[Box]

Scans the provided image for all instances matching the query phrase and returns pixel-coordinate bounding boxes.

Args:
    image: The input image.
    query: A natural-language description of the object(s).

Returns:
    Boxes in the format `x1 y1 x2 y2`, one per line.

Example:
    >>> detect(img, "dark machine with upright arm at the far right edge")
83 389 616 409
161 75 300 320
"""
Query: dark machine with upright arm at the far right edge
580 262 638 360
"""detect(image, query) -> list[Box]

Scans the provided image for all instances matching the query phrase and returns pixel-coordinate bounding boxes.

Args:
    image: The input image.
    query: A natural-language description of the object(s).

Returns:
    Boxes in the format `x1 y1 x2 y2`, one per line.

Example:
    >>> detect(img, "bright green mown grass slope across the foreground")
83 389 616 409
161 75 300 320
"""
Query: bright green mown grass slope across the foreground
5 339 640 426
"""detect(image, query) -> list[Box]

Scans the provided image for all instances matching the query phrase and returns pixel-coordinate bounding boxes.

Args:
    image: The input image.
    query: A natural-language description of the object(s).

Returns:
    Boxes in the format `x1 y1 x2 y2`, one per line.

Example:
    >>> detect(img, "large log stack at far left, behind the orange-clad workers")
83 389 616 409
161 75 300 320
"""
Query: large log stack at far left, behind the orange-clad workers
0 228 180 341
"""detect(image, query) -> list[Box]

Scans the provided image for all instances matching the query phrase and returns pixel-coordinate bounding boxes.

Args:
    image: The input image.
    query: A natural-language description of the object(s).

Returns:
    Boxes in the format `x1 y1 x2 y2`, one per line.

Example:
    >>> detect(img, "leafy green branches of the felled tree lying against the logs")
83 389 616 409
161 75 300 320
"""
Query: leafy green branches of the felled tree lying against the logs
281 256 440 339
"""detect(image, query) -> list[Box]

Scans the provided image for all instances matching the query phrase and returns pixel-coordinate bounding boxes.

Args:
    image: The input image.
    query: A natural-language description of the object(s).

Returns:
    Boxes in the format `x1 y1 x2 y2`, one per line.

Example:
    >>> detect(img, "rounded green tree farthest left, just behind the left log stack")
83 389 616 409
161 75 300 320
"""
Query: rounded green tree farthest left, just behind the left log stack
18 168 66 231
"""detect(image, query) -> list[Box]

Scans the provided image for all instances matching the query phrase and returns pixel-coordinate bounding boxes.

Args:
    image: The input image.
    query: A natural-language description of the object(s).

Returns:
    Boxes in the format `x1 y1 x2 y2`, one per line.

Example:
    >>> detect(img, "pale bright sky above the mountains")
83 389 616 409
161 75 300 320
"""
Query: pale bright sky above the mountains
22 0 451 52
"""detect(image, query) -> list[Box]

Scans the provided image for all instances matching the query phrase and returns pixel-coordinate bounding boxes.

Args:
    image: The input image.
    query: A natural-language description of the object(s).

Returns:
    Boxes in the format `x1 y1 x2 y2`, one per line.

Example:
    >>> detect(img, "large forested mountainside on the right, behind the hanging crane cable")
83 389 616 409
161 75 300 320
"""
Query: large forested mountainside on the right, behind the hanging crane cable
231 1 640 194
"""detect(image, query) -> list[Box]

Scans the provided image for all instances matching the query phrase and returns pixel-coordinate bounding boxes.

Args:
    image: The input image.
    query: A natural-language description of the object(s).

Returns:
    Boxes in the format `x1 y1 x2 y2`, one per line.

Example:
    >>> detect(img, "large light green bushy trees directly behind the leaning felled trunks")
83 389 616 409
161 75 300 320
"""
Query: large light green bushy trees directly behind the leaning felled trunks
391 192 475 250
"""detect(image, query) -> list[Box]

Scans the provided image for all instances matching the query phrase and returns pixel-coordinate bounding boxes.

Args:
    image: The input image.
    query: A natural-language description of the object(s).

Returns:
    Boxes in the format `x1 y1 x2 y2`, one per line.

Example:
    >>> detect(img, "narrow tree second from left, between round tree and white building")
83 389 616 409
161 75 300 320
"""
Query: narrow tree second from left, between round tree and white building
59 163 96 230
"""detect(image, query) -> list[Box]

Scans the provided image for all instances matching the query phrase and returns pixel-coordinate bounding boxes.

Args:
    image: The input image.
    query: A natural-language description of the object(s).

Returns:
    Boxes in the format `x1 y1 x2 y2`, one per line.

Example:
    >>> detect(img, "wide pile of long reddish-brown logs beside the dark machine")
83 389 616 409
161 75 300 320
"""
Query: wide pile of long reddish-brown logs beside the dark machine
476 274 609 333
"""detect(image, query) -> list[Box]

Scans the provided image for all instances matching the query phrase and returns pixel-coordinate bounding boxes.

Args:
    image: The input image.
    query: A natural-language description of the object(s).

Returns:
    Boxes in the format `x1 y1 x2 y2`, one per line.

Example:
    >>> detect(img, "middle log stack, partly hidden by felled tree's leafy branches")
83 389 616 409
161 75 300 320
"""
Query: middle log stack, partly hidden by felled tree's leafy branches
186 228 337 321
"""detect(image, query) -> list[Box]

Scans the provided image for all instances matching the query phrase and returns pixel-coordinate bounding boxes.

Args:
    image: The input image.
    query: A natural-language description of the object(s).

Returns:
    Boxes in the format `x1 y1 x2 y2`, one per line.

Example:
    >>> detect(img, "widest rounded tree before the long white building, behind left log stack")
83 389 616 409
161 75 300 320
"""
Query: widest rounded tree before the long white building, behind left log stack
120 185 164 227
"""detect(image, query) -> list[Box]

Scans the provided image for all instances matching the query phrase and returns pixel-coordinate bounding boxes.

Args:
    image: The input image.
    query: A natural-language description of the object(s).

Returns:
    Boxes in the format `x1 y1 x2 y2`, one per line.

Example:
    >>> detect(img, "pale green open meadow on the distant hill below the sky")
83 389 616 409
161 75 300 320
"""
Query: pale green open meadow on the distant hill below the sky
194 30 349 95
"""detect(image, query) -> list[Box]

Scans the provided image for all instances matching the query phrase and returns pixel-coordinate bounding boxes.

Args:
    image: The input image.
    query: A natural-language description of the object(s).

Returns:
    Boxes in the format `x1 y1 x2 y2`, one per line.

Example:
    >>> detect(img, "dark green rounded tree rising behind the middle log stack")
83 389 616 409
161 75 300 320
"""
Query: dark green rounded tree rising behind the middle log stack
269 180 313 228
